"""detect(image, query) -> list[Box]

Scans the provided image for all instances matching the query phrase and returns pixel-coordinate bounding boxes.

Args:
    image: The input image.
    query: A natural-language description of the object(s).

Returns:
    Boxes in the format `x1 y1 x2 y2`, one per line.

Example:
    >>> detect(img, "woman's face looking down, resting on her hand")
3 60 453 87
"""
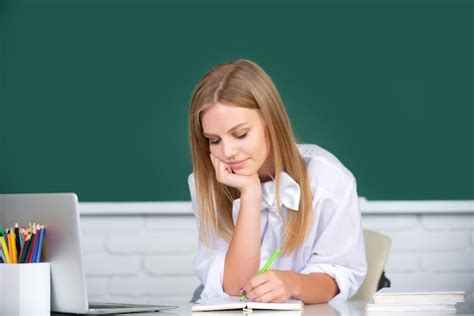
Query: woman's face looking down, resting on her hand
201 103 274 179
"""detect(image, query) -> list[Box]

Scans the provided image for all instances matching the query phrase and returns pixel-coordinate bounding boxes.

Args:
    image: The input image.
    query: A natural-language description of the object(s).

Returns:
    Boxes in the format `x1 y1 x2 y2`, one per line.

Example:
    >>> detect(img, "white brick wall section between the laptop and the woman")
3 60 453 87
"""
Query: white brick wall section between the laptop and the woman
81 215 199 304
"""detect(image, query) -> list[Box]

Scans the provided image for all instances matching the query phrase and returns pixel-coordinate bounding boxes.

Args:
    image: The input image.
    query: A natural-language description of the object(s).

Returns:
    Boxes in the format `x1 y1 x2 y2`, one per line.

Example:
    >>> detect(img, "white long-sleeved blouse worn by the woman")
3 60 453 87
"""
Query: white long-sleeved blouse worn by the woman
188 145 367 301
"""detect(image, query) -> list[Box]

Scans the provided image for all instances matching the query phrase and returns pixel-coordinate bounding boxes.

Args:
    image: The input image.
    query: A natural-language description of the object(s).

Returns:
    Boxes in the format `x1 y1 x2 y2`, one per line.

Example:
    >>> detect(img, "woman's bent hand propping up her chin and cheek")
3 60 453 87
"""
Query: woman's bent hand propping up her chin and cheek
210 153 260 193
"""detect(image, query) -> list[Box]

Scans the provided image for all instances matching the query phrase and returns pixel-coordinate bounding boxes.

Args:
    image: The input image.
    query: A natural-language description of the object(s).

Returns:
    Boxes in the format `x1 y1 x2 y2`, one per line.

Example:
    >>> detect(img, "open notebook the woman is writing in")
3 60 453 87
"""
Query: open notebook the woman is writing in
191 296 303 312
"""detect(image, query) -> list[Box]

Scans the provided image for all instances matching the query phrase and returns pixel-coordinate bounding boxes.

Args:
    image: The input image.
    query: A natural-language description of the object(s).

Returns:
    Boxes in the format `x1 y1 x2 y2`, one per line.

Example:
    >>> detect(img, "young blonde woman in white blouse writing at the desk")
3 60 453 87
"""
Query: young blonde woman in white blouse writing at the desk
188 60 367 304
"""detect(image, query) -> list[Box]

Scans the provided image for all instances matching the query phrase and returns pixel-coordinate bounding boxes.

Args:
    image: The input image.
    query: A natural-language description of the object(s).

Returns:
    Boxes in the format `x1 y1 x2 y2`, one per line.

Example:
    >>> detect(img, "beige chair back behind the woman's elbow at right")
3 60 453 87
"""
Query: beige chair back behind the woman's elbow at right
352 229 392 300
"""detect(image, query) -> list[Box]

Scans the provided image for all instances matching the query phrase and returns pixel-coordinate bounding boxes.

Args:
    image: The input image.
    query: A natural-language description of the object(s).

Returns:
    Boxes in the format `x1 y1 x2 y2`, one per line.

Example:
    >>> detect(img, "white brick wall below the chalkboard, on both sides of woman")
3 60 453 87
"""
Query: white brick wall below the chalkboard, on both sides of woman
81 202 474 304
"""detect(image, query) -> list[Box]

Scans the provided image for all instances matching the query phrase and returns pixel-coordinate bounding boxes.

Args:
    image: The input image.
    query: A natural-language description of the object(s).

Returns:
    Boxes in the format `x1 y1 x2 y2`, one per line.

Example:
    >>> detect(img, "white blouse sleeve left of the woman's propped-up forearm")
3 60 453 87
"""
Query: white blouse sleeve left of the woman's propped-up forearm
188 174 229 298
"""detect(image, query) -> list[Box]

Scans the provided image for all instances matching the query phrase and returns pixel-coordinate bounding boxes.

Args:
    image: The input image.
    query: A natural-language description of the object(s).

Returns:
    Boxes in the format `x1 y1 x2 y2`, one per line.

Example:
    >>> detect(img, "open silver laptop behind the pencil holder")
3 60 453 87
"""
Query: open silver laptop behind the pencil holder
0 193 176 315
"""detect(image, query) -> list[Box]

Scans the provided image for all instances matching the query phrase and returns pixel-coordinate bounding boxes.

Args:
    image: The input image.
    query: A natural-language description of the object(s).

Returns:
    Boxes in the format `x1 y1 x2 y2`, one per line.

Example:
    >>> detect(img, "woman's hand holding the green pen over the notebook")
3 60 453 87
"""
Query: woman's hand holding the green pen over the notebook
242 270 296 303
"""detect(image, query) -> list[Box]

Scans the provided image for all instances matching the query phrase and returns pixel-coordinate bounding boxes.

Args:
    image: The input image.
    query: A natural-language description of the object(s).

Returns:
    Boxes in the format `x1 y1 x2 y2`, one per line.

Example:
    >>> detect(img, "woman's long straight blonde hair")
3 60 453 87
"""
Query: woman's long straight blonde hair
189 59 312 254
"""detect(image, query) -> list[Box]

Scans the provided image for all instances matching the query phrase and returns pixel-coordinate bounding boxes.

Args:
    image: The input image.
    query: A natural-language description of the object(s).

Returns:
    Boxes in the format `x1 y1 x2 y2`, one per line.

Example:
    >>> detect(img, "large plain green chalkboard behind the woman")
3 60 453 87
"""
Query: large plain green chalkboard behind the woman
0 0 474 201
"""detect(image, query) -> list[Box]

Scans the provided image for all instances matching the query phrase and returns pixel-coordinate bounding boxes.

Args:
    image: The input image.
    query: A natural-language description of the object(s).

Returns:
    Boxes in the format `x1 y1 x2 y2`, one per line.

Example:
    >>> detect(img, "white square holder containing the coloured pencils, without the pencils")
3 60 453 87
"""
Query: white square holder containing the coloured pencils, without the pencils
0 263 51 315
